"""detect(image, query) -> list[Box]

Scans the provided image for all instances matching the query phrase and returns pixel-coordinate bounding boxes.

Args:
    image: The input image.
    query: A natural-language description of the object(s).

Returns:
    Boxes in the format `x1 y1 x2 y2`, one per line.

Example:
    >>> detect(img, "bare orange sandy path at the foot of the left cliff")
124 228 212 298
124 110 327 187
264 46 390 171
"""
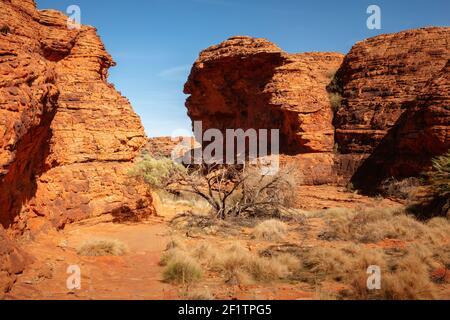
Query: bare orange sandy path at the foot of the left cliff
8 218 178 299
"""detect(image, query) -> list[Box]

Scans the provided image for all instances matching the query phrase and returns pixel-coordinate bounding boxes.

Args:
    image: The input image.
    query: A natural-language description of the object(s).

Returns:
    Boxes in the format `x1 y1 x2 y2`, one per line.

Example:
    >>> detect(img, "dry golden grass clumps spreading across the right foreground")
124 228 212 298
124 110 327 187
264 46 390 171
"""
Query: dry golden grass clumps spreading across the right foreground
161 202 450 300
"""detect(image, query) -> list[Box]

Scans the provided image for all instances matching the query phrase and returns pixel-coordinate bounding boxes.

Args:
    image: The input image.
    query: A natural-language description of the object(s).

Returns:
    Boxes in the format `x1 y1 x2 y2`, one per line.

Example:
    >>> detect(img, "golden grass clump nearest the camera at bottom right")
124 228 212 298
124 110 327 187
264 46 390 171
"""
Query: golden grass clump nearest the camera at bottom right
299 244 440 300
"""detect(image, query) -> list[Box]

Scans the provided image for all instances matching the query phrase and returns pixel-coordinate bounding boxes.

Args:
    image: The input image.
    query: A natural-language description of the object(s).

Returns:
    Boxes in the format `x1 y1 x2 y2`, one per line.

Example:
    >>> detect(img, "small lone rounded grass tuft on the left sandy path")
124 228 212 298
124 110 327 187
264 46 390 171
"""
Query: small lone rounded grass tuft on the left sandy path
77 239 127 257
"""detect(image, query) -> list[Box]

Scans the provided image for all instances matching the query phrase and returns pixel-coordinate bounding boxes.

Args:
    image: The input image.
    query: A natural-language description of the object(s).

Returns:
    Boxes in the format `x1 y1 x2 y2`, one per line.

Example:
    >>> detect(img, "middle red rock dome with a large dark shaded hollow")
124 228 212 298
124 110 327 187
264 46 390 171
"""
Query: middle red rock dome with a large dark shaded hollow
184 37 343 154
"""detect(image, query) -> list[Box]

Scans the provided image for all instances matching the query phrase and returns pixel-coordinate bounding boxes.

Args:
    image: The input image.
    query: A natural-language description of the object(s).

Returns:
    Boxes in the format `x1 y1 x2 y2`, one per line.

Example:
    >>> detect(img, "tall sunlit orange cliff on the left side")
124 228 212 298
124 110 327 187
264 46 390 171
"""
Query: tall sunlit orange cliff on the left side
0 0 152 230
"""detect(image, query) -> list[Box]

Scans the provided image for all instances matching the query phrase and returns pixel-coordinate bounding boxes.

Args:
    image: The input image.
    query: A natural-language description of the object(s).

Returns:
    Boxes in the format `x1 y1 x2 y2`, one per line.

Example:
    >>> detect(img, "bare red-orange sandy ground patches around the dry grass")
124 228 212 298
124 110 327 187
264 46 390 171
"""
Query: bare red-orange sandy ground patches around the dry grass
6 186 448 300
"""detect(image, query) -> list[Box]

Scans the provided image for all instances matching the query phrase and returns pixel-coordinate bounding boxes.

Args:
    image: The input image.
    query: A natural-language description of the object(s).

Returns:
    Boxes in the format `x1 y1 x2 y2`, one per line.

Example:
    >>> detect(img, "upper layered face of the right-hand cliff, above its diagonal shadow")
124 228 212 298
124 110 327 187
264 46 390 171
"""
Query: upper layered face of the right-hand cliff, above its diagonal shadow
334 28 450 154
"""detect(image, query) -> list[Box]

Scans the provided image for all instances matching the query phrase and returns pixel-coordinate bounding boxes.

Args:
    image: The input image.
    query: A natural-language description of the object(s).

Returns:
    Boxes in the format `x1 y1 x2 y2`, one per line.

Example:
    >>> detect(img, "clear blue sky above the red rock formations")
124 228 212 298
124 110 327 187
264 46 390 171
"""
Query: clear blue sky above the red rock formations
36 0 450 137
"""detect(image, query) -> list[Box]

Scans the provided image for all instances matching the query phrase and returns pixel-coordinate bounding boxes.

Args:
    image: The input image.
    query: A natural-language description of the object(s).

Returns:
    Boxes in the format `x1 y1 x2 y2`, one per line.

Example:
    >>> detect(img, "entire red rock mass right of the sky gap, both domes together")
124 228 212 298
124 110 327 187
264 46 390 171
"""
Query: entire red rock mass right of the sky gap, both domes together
185 28 450 187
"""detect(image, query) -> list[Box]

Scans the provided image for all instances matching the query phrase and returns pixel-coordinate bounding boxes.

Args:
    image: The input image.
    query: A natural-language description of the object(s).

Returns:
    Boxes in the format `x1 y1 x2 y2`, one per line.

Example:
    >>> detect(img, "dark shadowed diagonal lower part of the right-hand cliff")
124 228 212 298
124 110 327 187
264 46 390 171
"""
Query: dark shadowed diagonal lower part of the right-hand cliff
353 60 450 190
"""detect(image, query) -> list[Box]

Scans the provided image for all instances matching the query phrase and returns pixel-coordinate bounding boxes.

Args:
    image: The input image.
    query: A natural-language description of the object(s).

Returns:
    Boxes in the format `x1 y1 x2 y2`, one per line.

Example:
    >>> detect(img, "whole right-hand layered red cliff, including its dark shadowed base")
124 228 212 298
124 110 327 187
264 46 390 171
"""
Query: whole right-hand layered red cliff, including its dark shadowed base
334 28 450 189
